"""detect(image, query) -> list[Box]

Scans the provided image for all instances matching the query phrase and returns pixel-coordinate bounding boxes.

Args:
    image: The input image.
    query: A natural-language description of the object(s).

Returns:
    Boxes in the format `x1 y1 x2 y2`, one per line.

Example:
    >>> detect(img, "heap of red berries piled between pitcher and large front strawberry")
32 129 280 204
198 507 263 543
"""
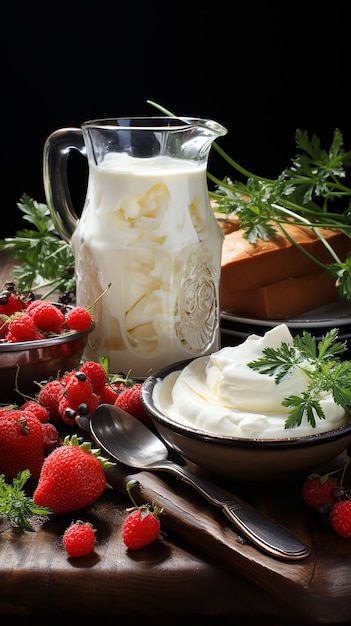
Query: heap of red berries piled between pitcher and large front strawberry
0 361 151 478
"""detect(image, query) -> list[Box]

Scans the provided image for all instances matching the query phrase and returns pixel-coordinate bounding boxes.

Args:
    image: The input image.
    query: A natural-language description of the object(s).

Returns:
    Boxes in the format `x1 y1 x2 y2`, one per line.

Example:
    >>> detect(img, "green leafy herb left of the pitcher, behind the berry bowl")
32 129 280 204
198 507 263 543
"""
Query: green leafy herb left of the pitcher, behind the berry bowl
0 194 76 298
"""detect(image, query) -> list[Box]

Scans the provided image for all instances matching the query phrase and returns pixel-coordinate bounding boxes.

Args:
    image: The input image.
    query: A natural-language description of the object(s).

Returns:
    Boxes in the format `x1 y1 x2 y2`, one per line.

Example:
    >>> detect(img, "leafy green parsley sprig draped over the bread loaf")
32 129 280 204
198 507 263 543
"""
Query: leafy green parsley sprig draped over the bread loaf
208 129 351 300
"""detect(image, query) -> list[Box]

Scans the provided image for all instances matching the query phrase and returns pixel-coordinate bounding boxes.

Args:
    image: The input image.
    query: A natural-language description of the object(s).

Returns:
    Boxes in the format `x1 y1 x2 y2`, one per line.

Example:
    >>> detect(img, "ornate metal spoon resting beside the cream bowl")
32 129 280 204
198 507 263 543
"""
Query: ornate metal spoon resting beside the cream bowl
90 404 310 561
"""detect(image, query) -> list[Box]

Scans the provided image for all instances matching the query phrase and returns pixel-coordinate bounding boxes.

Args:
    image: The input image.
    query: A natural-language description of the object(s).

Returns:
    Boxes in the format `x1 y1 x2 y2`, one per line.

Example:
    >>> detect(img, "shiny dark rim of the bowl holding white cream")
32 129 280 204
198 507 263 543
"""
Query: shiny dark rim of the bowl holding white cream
141 359 351 450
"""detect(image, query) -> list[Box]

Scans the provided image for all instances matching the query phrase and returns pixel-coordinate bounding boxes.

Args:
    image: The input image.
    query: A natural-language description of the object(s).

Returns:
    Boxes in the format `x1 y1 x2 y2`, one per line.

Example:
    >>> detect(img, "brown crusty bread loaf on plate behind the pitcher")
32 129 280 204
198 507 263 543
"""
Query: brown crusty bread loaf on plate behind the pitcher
220 225 351 319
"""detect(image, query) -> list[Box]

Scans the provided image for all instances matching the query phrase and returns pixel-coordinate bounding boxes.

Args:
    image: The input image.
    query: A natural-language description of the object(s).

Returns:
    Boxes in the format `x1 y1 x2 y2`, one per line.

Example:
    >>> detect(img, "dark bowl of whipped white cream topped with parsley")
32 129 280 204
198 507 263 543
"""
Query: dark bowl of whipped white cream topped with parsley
141 324 351 484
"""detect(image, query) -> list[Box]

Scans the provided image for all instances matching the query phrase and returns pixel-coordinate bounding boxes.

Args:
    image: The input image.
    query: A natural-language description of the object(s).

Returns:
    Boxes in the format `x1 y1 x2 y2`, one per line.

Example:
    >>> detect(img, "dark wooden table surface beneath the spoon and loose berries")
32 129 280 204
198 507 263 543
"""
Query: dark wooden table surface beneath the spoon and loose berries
0 251 351 626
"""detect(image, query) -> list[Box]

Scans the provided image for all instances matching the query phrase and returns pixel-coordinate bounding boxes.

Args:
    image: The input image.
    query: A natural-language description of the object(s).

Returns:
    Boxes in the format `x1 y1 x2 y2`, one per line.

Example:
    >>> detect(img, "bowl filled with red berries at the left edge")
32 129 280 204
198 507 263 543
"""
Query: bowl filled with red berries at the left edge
0 283 95 404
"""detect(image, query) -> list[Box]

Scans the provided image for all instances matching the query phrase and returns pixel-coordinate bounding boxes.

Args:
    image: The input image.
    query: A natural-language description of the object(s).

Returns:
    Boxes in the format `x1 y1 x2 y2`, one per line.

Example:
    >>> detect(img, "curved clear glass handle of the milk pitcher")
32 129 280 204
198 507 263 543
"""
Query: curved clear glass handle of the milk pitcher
43 128 86 242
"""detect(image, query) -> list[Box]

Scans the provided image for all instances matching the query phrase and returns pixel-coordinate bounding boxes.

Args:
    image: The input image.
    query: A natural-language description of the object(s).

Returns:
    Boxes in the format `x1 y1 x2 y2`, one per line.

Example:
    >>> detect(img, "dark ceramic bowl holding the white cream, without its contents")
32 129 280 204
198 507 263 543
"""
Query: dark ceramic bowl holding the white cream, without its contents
141 361 351 484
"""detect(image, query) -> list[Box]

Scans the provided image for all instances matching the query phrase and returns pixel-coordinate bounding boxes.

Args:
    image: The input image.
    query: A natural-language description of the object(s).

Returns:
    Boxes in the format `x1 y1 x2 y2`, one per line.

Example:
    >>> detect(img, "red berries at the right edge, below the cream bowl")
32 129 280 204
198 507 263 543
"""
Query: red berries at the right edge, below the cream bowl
302 461 351 537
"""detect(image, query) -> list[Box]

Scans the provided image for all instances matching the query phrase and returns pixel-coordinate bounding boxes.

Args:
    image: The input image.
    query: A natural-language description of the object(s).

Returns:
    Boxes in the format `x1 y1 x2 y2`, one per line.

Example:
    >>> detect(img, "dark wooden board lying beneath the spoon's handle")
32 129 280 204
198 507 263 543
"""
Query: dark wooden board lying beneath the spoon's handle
104 453 351 623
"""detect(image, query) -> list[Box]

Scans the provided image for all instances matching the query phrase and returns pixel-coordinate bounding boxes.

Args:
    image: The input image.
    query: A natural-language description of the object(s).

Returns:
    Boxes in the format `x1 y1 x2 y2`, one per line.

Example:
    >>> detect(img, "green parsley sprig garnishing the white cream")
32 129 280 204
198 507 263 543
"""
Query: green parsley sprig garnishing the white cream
248 328 351 428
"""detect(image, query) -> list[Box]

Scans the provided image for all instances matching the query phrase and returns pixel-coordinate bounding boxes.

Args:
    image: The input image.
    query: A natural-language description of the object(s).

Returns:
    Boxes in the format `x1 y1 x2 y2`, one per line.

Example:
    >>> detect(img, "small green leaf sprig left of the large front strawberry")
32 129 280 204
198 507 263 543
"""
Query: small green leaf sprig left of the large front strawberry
0 470 53 532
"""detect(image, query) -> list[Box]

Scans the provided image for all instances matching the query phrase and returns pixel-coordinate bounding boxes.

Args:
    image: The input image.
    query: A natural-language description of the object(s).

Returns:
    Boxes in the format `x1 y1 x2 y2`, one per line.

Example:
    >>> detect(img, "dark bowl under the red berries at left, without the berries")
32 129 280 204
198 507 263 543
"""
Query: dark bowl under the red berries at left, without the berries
0 304 95 404
